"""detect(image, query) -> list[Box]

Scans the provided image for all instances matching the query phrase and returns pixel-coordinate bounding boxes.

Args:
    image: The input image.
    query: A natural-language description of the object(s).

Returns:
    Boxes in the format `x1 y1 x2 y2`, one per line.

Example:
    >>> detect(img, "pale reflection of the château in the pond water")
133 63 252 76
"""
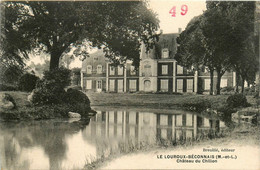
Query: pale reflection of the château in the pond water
83 111 225 157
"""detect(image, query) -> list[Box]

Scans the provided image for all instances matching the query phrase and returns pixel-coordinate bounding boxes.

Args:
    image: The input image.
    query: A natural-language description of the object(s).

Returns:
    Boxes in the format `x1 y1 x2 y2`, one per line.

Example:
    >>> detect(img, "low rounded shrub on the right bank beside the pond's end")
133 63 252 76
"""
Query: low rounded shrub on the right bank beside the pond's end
227 93 249 108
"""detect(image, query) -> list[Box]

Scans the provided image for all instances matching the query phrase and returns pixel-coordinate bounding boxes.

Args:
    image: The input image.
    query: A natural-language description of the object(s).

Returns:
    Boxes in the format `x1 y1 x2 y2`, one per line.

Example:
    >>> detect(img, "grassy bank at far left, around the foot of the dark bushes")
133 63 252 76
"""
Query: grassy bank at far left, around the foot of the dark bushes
0 91 90 120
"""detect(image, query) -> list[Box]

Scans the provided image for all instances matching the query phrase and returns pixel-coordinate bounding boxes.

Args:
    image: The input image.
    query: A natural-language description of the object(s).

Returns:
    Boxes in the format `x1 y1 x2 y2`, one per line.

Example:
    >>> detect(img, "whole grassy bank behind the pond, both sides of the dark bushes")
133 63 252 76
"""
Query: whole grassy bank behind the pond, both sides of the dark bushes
0 91 257 119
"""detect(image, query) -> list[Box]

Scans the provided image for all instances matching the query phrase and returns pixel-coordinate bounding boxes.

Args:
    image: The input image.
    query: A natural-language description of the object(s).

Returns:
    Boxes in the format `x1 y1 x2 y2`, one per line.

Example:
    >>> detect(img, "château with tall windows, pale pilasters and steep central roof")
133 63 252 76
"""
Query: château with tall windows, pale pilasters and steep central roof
81 33 236 93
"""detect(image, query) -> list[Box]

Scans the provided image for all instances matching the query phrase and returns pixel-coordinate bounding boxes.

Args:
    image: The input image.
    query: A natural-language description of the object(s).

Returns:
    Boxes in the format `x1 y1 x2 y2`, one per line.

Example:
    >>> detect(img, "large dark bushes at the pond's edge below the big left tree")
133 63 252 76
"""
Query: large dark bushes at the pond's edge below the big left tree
32 68 91 115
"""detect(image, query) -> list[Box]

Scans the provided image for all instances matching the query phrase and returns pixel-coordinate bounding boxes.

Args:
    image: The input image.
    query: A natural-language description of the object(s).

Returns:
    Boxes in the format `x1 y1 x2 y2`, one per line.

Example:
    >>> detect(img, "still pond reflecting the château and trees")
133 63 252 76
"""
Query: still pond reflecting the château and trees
0 108 225 169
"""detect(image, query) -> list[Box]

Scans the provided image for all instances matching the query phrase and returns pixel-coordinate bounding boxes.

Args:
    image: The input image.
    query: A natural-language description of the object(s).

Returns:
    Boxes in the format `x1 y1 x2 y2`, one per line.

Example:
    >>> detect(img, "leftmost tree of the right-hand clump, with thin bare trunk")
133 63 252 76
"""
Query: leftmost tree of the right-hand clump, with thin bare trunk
175 15 214 95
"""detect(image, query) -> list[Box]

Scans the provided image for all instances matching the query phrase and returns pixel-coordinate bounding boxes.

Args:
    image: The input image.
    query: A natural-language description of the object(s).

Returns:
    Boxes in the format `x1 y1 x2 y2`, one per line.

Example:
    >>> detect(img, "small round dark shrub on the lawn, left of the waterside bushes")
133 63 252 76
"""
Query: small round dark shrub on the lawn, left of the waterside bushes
18 73 39 92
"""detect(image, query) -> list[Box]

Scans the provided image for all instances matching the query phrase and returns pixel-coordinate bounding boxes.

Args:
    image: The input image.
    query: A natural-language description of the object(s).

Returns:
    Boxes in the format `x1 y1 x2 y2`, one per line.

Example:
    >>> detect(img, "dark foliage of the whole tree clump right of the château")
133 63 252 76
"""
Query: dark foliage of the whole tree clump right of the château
176 1 259 94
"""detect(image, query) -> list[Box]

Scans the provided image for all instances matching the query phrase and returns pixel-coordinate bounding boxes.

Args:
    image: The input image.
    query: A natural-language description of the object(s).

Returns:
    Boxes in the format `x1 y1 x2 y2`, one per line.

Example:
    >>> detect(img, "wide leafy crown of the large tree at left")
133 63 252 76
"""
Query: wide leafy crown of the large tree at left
1 1 159 69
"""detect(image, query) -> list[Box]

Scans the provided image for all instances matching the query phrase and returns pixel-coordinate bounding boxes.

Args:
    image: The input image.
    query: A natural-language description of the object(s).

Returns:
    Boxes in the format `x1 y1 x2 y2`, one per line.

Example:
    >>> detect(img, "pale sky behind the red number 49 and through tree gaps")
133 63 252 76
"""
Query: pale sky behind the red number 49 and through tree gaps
27 0 206 68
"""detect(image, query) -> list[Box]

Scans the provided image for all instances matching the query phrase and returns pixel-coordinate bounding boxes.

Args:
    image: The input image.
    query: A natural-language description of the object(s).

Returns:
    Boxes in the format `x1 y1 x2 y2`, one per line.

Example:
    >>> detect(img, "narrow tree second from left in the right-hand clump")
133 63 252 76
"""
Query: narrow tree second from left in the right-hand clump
200 5 232 95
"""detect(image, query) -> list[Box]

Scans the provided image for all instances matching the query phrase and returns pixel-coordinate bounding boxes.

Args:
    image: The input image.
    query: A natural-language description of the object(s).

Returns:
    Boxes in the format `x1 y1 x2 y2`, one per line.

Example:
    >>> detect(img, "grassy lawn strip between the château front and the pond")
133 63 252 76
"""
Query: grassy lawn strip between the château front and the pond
86 93 257 110
